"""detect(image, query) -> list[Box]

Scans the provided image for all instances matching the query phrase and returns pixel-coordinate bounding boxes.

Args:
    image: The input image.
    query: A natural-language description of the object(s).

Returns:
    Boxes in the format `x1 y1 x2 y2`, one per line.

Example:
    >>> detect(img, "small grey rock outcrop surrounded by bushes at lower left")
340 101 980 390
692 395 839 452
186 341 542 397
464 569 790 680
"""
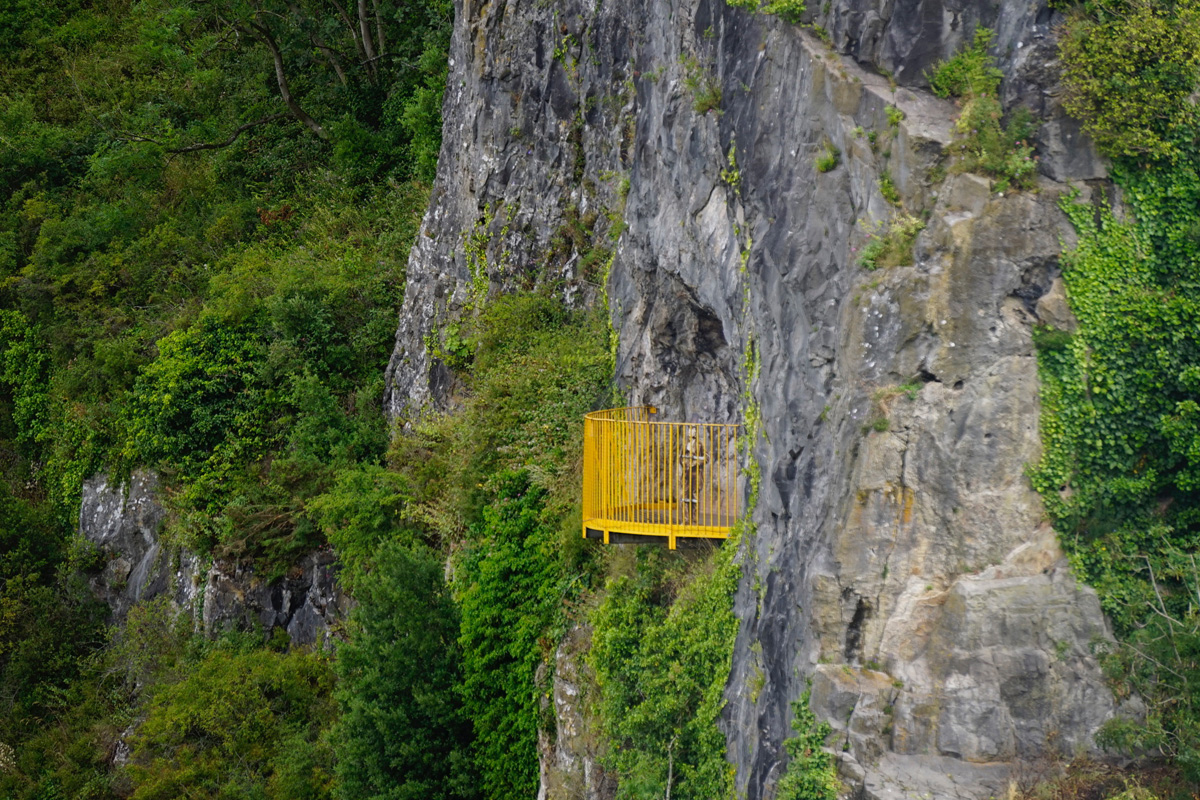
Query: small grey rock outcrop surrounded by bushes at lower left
79 470 349 645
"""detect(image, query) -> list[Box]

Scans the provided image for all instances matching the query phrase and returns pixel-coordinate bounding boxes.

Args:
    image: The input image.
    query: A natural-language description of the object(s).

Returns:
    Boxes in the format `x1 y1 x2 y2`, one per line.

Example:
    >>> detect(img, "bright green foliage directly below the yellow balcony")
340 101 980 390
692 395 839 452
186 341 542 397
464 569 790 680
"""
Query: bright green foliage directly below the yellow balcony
588 535 740 800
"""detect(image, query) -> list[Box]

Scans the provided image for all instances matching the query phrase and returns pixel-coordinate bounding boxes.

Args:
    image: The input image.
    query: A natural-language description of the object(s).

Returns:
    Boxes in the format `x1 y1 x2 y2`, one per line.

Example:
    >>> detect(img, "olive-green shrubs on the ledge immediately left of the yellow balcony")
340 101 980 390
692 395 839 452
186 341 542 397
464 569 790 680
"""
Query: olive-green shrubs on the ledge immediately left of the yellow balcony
405 293 612 532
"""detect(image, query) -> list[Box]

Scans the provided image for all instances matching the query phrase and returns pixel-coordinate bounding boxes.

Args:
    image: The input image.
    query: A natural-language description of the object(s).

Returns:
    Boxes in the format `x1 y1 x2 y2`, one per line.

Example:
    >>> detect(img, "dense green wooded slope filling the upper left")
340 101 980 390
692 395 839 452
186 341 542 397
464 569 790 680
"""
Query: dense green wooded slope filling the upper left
0 0 441 544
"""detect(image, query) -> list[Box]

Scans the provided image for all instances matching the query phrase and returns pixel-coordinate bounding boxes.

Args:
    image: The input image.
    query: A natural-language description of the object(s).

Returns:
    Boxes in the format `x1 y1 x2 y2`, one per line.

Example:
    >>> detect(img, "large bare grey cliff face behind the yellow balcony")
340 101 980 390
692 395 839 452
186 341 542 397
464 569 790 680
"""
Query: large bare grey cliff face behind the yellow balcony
388 0 1117 800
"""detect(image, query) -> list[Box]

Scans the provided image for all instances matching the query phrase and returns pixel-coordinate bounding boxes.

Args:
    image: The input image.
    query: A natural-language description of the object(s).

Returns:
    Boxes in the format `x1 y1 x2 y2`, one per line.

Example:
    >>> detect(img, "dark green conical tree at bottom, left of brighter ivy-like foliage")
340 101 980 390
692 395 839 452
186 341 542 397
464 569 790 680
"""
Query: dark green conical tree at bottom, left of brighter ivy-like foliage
332 542 479 800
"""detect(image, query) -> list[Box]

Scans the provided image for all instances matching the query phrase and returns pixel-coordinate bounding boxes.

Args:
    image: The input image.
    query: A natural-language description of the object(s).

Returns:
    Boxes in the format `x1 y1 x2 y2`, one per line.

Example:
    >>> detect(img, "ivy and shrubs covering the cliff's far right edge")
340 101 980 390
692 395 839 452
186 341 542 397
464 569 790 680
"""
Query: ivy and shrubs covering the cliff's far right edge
1031 2 1200 784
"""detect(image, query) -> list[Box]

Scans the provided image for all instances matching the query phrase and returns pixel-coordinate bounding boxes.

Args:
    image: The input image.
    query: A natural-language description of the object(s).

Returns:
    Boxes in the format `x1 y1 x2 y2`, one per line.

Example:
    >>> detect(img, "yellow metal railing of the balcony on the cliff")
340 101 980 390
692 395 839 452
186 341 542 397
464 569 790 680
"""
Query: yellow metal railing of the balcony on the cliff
583 405 740 549
